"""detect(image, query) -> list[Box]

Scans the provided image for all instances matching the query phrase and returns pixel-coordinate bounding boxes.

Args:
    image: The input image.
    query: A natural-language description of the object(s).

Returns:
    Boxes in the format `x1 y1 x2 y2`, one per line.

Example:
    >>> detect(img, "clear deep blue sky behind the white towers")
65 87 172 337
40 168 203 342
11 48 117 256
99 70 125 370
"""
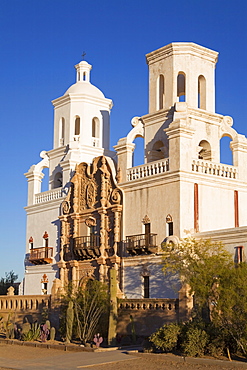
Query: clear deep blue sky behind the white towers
0 0 247 277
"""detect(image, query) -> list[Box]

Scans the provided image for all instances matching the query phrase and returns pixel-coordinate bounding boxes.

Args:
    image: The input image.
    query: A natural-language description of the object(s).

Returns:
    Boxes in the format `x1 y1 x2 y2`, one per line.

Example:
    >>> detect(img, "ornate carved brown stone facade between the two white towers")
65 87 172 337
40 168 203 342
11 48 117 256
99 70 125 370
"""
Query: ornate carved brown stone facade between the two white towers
59 156 123 285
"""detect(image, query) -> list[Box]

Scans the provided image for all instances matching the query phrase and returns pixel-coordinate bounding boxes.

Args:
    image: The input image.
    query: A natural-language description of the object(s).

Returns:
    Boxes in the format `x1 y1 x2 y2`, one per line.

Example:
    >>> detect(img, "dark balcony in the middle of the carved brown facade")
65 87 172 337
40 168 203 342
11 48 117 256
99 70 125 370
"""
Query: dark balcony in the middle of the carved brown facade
73 235 100 260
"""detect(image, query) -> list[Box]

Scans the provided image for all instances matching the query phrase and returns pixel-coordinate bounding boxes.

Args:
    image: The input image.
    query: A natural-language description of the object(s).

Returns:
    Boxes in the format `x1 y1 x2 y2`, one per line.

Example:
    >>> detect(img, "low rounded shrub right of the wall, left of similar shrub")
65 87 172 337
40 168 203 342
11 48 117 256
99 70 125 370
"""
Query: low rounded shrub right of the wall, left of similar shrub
150 323 181 352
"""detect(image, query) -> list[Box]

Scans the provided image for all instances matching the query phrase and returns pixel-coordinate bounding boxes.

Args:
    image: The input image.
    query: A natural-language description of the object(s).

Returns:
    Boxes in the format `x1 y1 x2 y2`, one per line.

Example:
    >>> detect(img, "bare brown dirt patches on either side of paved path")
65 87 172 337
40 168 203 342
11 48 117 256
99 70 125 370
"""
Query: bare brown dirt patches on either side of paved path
0 343 247 370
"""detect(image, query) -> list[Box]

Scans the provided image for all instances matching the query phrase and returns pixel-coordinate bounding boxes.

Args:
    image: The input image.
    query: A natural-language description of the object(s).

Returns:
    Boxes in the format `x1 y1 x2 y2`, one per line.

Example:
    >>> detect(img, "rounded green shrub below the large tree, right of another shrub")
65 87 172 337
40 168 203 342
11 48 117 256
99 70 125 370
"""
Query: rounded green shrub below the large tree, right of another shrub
181 325 209 357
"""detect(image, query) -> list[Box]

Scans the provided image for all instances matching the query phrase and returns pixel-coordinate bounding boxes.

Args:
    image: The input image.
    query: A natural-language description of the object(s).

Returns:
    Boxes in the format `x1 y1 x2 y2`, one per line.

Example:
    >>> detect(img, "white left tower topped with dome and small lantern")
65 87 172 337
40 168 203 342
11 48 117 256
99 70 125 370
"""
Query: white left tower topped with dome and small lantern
52 61 112 156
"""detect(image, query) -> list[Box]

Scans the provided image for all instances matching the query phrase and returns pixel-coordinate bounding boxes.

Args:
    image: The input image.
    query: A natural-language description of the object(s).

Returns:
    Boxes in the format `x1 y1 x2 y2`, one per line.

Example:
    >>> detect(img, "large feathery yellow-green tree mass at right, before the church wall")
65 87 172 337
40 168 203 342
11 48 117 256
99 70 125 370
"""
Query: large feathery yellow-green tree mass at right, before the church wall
163 239 247 355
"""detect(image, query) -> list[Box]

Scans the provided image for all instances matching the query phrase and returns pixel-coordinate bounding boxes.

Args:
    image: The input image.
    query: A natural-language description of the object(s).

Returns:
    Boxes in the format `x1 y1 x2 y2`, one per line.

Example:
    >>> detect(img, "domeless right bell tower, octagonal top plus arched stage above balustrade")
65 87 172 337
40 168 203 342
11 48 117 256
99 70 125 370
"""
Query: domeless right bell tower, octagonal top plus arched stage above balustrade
142 42 219 166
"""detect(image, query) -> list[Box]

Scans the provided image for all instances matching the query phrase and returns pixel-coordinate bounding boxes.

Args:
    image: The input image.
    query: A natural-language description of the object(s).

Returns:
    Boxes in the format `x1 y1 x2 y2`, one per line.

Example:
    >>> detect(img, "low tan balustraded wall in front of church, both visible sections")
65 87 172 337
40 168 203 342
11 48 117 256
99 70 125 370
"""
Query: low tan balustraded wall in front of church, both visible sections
0 289 192 337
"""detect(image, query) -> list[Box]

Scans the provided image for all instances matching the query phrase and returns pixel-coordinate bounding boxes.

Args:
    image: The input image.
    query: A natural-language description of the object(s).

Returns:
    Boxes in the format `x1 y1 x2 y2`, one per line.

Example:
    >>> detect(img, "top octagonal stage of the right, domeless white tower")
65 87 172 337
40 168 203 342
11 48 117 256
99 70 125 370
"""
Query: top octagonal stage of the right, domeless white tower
146 42 218 113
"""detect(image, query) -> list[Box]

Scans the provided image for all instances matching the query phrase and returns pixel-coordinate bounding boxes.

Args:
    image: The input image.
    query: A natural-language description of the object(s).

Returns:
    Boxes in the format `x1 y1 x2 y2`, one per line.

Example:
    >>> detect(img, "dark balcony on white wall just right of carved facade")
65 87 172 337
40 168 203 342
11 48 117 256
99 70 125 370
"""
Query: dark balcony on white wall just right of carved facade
124 233 158 256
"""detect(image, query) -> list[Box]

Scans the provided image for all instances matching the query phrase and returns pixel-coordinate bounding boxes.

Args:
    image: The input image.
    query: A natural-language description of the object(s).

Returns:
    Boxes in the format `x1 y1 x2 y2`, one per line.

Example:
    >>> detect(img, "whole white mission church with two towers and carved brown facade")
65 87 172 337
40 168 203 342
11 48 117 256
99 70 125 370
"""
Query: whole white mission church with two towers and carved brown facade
23 42 247 306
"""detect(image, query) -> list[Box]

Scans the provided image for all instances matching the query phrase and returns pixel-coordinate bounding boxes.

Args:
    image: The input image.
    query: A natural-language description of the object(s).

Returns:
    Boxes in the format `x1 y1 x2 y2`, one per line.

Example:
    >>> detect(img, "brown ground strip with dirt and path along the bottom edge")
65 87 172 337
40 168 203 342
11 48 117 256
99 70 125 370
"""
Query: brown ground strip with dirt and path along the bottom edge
0 343 247 370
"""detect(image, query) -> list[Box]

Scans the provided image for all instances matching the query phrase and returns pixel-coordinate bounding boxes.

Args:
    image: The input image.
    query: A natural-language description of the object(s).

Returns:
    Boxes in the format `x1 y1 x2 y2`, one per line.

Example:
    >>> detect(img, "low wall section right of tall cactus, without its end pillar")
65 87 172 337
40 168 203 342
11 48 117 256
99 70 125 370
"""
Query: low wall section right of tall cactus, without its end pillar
116 298 179 337
